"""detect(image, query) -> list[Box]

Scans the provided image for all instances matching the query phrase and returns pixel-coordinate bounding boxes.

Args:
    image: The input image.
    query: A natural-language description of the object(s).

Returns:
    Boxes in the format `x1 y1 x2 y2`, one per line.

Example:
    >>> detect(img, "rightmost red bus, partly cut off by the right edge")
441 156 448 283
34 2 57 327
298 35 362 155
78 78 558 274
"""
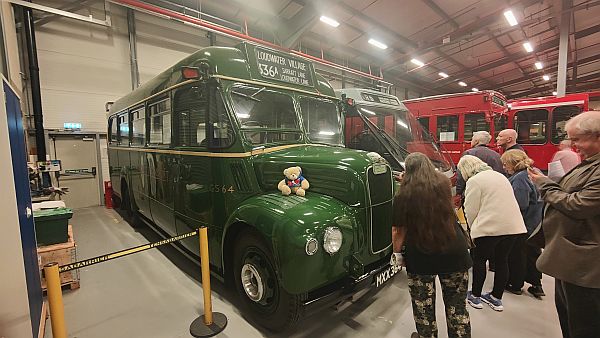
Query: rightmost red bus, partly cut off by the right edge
508 93 600 170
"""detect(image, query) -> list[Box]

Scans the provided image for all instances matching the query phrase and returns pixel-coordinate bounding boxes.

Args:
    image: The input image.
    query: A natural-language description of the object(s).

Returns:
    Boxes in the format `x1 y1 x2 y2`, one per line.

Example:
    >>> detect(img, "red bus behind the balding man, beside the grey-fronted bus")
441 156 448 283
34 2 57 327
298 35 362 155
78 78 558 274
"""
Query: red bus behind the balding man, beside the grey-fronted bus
402 90 508 163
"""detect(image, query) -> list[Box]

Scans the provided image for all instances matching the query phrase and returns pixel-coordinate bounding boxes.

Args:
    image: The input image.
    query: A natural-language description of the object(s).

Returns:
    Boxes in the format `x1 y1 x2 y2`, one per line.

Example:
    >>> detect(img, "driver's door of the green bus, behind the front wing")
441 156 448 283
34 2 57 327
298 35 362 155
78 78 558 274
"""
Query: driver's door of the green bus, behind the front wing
173 83 213 253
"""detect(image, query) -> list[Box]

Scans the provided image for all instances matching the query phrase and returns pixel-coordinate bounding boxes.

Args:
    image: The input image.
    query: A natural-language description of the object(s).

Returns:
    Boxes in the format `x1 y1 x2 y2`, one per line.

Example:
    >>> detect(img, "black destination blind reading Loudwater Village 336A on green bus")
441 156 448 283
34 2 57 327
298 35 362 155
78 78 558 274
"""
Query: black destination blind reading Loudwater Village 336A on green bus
256 47 313 87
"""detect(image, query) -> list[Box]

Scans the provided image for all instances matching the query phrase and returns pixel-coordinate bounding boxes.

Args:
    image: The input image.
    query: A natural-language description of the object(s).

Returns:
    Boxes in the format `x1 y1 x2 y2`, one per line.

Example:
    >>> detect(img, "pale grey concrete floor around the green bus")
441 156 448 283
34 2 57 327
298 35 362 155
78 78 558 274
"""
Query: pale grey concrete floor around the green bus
45 207 561 338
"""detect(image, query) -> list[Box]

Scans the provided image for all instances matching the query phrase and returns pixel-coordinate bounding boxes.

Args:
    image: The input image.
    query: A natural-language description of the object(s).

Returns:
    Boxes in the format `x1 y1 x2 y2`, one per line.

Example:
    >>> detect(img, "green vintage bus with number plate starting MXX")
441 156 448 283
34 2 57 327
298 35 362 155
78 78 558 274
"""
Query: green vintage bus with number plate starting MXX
108 43 396 330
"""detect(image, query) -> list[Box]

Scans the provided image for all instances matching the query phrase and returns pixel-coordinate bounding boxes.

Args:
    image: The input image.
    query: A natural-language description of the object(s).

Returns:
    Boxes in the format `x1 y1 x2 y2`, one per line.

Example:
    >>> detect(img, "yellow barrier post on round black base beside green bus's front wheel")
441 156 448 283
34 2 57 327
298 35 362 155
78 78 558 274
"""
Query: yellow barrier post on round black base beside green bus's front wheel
190 227 227 337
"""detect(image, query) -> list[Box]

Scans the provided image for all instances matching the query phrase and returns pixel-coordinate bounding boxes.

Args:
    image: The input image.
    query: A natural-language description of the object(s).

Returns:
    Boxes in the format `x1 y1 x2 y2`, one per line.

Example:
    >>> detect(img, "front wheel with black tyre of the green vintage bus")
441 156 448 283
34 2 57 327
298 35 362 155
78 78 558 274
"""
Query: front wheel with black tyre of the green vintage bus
233 231 305 331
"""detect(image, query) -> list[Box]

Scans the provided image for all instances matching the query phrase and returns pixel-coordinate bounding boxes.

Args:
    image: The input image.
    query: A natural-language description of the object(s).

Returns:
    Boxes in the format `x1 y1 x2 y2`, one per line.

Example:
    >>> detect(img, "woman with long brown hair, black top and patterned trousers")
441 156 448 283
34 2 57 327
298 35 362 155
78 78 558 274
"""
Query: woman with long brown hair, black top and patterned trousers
392 153 472 337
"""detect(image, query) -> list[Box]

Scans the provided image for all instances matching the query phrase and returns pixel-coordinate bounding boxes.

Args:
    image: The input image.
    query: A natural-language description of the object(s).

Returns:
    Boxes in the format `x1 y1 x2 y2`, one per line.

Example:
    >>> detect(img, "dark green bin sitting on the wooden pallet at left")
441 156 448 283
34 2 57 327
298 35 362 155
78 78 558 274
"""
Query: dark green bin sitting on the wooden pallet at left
33 208 73 246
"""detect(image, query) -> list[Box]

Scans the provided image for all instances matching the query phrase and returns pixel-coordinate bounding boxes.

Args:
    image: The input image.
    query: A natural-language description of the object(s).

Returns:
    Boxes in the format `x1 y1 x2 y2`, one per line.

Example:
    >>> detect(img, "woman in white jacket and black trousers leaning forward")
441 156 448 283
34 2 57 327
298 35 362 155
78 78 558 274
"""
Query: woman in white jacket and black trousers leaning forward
458 155 527 311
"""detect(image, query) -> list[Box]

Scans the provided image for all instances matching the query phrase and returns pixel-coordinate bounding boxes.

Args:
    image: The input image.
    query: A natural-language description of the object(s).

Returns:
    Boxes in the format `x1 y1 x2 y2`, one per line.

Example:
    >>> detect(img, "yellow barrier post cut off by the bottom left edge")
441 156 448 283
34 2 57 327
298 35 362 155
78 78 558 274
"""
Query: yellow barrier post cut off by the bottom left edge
44 263 67 338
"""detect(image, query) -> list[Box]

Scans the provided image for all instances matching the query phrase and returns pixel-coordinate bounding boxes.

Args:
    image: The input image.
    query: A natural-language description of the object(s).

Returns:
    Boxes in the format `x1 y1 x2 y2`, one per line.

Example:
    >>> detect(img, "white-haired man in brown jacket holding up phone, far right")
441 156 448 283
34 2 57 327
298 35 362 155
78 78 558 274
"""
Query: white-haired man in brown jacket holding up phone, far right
529 111 600 338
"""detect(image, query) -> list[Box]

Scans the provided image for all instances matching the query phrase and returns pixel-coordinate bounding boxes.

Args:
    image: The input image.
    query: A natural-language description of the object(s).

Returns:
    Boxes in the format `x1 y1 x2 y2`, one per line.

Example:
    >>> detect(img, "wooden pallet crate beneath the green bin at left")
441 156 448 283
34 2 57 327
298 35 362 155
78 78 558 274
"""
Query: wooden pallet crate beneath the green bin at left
38 225 79 291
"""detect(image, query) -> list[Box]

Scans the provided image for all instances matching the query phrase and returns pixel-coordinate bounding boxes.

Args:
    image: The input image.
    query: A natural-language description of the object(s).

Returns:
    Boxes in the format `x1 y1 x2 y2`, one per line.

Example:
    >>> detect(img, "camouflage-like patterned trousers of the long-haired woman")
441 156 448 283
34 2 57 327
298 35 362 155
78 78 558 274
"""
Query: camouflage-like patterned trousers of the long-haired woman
408 271 471 338
